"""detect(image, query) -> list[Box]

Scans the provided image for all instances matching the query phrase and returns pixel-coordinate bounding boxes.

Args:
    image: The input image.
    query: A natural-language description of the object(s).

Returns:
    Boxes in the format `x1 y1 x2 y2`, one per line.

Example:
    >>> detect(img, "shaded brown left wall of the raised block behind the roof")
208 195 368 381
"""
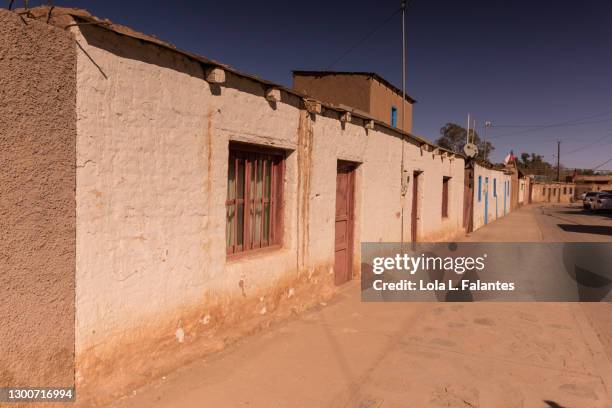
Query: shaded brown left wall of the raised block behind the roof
293 74 368 113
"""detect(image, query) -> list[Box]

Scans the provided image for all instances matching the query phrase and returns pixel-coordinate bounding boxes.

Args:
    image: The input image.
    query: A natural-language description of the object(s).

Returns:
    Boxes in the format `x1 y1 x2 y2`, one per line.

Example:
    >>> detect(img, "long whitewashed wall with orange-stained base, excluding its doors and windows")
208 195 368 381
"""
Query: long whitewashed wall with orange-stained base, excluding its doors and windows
73 18 463 403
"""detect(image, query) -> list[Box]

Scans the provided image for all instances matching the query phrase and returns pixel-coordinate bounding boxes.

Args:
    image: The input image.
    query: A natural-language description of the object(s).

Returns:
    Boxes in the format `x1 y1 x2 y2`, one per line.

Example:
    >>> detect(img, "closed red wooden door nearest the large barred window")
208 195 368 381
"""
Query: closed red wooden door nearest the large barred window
334 162 355 285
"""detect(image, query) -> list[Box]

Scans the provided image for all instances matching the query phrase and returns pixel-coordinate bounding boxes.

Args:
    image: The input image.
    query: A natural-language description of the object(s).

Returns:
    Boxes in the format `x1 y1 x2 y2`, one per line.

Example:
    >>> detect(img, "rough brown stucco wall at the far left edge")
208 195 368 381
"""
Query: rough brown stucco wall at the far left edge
0 9 76 387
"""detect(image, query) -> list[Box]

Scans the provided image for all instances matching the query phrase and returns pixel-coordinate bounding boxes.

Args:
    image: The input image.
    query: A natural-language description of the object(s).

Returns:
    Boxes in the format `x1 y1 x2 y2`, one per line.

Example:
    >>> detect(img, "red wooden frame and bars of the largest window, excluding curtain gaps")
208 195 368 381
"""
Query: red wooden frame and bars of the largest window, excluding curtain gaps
225 142 286 257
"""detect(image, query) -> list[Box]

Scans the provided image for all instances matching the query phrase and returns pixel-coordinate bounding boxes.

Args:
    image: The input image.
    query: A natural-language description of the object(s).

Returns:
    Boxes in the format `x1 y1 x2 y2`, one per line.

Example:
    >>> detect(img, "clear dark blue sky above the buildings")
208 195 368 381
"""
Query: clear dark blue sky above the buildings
30 0 612 169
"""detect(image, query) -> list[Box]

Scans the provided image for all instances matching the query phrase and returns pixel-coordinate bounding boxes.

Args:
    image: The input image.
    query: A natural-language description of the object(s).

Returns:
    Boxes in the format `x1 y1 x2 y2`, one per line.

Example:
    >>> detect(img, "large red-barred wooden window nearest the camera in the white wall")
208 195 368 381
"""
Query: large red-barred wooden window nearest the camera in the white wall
225 144 285 254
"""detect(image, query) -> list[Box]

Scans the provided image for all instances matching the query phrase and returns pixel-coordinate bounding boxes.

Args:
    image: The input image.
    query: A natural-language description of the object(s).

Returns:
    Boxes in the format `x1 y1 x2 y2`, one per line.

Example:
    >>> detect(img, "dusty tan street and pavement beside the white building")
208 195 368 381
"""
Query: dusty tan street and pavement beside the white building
107 206 612 408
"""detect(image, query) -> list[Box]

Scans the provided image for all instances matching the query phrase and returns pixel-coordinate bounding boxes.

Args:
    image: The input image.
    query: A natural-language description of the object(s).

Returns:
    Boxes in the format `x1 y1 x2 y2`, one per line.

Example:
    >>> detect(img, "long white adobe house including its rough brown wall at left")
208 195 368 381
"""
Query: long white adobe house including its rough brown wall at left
0 7 478 407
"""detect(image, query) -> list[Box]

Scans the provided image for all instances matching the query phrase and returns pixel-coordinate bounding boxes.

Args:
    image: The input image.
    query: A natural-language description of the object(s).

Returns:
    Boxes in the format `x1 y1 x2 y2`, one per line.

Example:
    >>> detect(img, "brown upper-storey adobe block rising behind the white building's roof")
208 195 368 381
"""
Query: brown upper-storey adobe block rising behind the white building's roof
293 71 416 133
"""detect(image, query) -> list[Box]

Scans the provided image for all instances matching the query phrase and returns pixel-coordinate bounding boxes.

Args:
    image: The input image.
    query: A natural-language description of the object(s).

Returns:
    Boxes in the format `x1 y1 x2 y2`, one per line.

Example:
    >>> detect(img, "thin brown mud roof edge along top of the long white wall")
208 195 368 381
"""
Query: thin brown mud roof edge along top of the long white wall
20 6 454 160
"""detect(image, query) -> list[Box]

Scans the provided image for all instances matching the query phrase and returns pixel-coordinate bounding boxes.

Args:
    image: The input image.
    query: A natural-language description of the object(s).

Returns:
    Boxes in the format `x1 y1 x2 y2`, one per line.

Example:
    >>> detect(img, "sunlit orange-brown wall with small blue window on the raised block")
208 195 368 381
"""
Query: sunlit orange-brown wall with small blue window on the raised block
370 78 412 133
